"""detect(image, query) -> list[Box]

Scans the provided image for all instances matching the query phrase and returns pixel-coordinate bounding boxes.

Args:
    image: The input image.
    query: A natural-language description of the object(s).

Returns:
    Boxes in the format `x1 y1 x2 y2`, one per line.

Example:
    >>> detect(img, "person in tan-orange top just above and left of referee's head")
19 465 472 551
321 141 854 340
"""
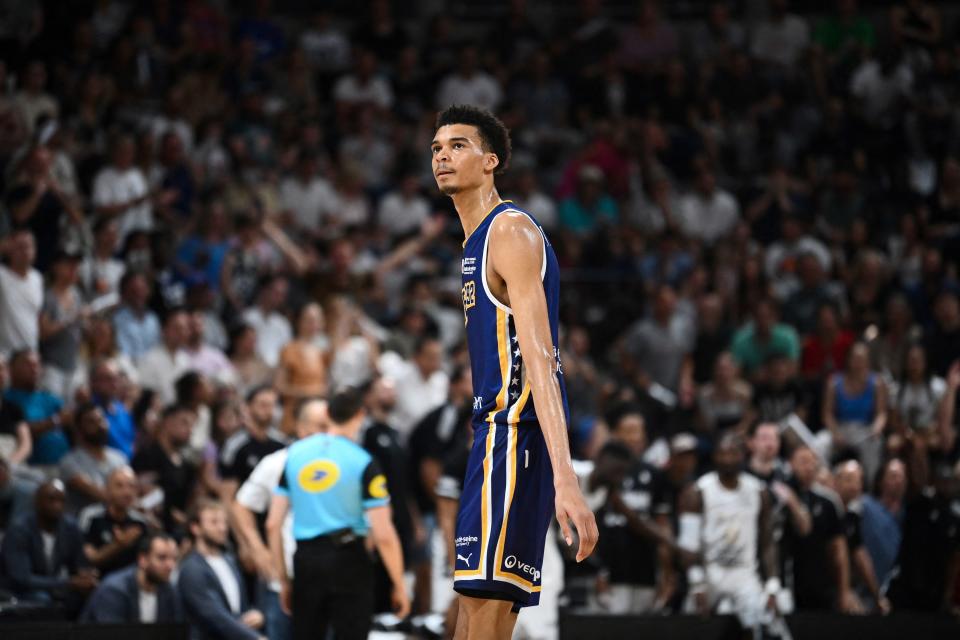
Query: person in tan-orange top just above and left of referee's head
274 302 329 435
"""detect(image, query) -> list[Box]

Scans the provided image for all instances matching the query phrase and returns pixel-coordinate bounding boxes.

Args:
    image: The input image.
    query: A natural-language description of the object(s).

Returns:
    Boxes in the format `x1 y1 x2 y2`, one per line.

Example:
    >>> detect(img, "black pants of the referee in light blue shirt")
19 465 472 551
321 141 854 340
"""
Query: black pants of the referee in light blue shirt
293 539 373 640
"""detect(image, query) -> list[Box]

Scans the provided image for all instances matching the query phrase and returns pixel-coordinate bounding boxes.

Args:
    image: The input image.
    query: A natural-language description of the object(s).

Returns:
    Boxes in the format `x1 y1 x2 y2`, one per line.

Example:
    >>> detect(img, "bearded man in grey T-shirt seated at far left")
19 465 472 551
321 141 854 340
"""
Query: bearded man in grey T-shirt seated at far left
60 403 127 514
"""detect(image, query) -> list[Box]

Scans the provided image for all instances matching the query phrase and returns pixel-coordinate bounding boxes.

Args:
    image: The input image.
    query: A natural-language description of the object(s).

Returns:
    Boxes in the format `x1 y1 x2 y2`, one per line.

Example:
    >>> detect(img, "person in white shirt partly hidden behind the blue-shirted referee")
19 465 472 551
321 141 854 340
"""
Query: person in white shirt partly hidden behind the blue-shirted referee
230 400 327 638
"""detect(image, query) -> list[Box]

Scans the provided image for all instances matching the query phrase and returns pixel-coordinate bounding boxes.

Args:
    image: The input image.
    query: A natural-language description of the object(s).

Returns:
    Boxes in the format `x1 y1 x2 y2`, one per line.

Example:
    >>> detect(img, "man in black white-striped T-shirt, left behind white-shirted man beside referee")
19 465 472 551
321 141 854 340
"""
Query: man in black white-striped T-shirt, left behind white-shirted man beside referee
219 387 284 500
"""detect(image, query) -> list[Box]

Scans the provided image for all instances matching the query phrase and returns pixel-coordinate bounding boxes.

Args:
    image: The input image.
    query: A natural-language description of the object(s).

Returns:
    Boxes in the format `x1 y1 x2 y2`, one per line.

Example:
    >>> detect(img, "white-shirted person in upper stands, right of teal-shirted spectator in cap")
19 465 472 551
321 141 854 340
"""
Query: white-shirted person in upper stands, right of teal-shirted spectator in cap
677 169 740 245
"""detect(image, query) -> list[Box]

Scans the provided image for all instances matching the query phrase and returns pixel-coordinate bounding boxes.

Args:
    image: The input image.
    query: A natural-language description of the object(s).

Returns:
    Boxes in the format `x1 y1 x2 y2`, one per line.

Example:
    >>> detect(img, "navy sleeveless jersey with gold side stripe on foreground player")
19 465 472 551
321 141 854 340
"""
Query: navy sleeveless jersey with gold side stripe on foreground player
461 201 566 426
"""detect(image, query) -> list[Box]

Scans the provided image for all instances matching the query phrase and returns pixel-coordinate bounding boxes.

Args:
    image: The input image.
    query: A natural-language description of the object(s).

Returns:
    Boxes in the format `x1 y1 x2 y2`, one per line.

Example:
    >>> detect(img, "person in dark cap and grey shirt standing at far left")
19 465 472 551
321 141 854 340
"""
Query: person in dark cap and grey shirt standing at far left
40 249 89 400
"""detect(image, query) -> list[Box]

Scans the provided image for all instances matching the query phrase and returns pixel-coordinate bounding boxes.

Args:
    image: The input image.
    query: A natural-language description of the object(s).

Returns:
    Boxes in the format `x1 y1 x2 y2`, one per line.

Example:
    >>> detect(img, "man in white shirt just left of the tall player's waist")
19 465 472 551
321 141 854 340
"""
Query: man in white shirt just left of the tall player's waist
379 337 450 441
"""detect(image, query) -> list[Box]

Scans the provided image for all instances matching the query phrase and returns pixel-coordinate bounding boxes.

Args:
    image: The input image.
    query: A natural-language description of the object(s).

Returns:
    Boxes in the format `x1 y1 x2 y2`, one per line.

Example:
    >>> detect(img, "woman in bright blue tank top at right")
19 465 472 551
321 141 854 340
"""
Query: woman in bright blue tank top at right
822 342 888 478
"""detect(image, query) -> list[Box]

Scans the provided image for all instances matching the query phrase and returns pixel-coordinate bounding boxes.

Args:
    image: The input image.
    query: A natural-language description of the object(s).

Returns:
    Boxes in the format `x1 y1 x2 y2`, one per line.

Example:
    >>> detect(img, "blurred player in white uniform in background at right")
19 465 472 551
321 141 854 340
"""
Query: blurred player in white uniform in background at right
679 434 781 632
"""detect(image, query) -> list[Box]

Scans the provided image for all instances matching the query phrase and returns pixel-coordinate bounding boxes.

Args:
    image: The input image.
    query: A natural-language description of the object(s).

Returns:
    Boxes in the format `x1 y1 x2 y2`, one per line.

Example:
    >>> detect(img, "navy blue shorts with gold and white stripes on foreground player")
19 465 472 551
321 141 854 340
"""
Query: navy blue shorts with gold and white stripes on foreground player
454 423 555 609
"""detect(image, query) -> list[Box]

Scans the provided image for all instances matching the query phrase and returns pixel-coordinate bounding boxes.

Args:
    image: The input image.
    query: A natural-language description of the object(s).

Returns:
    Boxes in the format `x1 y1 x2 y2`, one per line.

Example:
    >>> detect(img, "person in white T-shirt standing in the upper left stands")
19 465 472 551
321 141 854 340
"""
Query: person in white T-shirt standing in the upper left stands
93 135 153 242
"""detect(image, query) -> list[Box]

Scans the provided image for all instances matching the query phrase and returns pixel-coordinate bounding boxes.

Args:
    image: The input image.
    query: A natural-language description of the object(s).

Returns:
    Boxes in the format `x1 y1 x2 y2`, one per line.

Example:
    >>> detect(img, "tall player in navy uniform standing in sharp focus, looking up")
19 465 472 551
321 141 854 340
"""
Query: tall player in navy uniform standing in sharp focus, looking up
431 106 598 640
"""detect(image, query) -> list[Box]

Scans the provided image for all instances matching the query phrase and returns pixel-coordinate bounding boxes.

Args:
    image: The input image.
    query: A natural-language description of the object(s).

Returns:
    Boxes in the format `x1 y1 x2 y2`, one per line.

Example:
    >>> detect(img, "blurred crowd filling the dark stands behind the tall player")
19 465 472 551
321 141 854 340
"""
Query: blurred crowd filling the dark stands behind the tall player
0 0 960 628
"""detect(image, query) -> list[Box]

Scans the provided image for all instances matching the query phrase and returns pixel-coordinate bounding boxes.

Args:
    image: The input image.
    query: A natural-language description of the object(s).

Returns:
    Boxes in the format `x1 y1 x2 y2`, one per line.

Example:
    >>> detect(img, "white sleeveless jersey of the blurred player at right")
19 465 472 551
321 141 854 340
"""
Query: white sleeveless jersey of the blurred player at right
697 473 760 567
